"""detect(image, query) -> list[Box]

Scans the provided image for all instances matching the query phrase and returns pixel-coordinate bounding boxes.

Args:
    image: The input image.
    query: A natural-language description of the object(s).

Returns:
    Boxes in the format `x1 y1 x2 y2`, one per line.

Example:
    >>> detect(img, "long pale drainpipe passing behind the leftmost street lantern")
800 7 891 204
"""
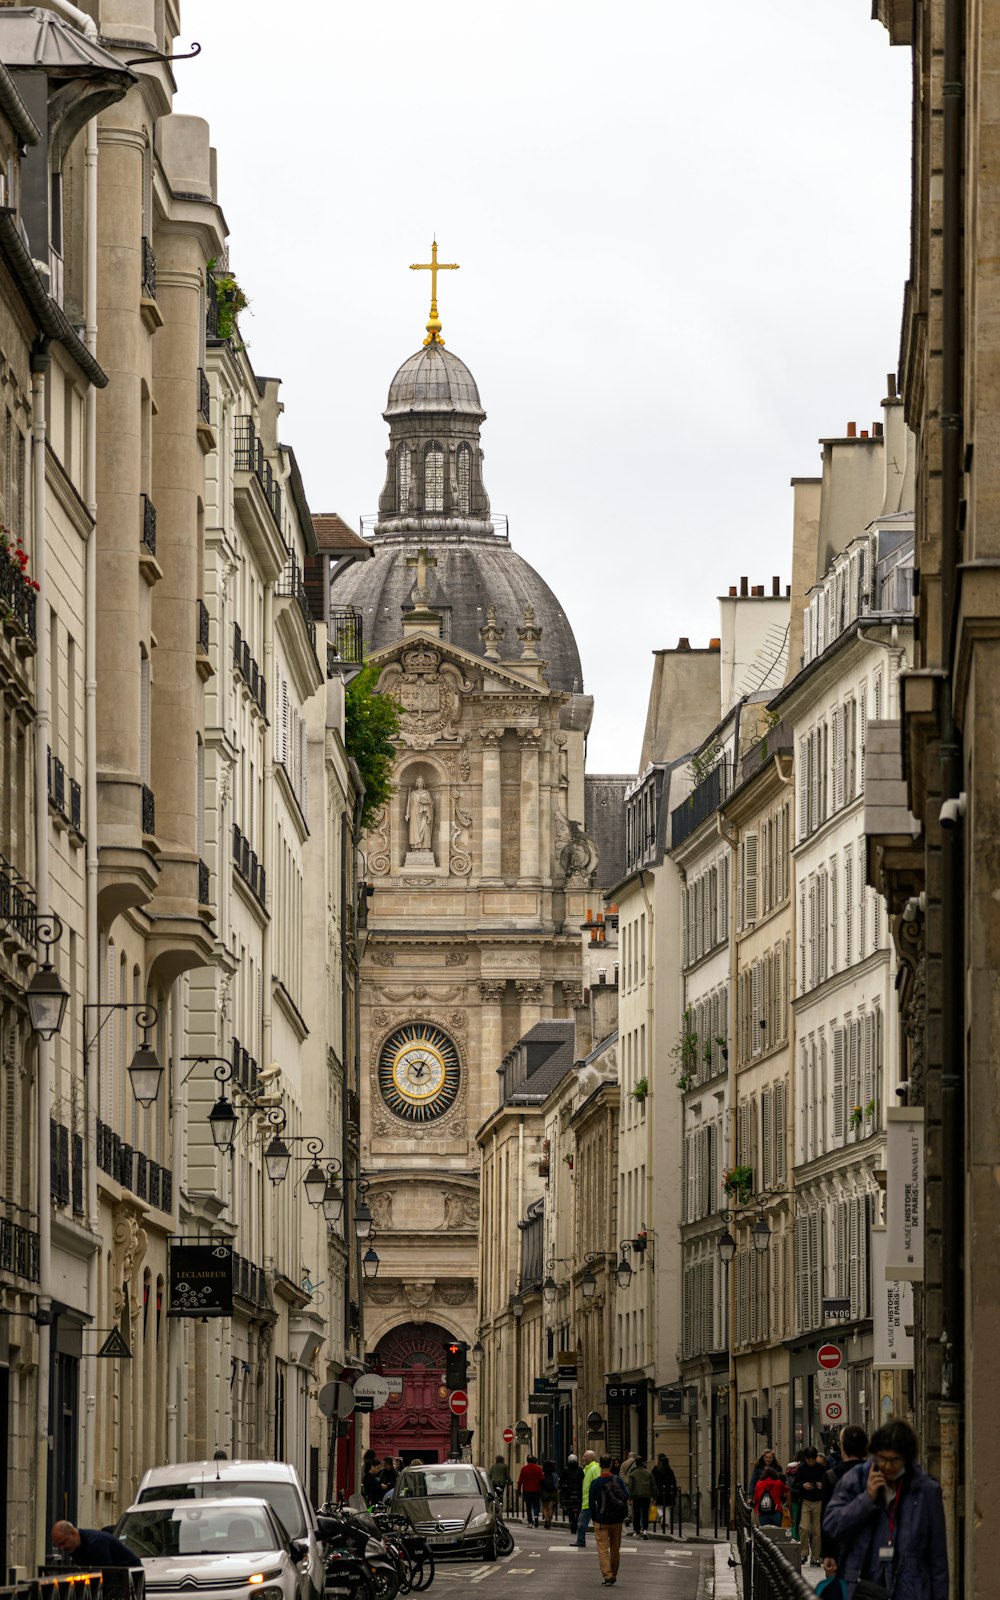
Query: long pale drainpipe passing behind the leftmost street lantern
32 338 53 1565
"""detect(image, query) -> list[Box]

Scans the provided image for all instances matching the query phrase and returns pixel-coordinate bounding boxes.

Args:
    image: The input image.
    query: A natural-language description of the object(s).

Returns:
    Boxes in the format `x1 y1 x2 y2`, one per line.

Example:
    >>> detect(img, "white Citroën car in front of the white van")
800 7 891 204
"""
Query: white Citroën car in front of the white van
115 1498 309 1600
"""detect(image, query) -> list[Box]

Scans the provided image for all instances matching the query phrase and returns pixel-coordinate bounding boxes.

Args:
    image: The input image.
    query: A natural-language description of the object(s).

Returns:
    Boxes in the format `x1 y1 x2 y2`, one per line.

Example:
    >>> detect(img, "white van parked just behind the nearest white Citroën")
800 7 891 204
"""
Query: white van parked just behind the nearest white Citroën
136 1458 326 1600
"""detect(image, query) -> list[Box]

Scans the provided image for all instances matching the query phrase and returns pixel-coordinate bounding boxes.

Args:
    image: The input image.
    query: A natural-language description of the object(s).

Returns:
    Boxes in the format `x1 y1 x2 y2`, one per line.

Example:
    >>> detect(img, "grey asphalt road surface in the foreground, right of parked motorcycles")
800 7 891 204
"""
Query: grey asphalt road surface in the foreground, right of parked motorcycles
427 1522 714 1600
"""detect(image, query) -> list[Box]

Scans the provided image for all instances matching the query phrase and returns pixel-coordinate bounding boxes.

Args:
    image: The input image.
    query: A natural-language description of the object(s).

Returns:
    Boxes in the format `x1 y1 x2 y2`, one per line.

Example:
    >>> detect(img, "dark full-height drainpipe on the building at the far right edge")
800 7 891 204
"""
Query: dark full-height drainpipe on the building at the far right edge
938 0 966 1592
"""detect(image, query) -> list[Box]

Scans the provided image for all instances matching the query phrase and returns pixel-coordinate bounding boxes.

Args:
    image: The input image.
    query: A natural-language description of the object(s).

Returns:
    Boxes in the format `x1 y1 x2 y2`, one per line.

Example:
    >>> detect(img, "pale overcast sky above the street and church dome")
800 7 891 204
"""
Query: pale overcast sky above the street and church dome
174 0 910 771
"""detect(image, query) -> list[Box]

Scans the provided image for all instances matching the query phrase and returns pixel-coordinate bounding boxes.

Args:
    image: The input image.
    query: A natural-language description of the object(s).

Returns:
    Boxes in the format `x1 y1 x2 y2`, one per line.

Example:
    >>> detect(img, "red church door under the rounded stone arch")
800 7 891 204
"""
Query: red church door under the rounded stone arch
370 1322 456 1461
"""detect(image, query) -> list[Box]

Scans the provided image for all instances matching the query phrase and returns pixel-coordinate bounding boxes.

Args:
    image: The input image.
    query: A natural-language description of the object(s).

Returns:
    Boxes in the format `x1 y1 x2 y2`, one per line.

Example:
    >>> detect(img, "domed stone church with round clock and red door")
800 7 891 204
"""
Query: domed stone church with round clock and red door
331 294 598 1459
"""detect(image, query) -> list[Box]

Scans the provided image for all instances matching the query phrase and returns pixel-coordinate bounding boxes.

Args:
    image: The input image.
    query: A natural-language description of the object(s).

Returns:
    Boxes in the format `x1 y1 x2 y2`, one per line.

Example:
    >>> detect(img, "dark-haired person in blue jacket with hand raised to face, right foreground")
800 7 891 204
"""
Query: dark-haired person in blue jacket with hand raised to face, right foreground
822 1422 947 1600
